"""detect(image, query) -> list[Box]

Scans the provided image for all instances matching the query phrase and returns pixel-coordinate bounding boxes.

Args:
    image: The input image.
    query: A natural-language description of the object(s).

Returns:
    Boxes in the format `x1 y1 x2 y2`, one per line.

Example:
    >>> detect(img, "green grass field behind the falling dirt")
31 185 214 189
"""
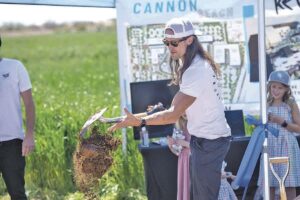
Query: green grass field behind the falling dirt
0 31 145 200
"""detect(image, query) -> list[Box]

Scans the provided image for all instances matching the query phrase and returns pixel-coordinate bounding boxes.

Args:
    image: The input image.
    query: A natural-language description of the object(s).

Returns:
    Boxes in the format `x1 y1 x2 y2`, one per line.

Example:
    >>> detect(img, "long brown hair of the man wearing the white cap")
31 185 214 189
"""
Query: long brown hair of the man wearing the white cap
170 35 221 85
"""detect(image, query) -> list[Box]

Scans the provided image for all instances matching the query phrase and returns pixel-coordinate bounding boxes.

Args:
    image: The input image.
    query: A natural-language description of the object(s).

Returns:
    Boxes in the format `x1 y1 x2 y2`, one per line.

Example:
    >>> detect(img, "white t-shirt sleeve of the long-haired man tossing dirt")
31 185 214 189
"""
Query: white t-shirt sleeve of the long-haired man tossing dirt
180 67 207 97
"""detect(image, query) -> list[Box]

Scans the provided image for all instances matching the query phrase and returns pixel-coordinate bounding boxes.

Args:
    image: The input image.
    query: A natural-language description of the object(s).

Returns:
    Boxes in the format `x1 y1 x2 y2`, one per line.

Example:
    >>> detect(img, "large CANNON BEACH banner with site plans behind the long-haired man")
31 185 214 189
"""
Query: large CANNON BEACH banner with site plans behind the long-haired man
116 0 300 113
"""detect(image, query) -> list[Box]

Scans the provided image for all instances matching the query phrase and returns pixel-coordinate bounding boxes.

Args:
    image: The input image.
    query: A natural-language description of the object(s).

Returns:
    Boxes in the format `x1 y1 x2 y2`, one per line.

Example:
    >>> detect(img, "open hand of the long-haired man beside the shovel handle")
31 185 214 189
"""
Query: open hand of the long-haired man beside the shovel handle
108 108 141 133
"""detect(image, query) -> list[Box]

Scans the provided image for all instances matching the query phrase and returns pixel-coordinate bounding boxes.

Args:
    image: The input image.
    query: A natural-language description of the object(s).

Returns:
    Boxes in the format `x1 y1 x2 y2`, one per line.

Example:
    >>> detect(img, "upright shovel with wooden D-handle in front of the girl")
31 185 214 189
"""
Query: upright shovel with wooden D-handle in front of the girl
269 157 290 200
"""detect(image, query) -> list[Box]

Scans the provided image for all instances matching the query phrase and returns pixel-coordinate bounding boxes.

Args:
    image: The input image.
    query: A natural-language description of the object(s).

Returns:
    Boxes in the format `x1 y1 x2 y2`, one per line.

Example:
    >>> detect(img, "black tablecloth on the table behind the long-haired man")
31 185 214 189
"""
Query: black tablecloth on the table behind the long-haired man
139 137 300 200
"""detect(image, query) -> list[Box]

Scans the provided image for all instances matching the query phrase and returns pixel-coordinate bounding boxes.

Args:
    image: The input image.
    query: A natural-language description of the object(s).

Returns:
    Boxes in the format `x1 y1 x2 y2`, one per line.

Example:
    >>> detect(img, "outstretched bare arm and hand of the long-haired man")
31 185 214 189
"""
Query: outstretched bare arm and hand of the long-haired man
108 91 196 132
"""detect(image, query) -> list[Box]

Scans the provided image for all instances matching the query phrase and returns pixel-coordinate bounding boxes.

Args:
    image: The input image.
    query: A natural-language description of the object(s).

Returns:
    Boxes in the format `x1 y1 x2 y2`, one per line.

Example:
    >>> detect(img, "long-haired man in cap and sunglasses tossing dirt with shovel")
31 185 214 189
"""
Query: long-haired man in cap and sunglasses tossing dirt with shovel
109 18 231 200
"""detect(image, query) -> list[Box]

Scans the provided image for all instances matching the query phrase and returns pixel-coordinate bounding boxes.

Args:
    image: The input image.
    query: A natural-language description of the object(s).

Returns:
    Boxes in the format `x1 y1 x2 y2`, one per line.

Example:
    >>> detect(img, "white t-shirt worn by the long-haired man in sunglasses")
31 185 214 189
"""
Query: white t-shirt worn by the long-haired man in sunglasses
180 55 231 139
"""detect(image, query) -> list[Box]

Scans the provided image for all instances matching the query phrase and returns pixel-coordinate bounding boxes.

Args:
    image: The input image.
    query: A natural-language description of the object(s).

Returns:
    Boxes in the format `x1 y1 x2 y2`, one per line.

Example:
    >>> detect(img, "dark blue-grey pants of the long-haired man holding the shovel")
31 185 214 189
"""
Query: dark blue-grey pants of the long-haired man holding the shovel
190 136 231 200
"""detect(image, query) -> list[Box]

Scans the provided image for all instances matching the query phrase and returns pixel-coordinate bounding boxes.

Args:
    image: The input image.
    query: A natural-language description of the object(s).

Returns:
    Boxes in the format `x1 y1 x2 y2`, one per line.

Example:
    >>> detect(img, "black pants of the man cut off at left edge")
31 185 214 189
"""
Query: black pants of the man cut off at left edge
0 139 27 200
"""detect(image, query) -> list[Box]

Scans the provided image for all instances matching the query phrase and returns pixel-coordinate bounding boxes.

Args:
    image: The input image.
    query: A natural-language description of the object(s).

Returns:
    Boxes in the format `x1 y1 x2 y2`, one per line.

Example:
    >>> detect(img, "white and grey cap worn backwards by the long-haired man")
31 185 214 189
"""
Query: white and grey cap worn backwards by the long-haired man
165 18 195 39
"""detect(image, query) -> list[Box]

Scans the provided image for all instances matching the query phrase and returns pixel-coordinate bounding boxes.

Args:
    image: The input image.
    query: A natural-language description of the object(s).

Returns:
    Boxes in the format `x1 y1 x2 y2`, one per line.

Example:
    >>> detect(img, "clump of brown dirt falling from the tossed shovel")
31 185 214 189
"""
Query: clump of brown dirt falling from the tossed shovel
73 126 121 199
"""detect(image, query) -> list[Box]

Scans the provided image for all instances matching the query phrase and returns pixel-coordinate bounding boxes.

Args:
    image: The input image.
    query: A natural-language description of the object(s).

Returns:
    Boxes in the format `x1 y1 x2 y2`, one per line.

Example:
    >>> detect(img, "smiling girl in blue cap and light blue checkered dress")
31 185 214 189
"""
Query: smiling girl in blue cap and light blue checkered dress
258 71 300 200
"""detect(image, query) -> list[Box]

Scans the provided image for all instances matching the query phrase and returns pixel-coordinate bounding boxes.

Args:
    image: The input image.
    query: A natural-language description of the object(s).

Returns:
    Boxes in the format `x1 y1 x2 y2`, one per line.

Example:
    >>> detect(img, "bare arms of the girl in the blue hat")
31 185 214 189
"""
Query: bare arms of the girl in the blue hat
268 102 300 133
